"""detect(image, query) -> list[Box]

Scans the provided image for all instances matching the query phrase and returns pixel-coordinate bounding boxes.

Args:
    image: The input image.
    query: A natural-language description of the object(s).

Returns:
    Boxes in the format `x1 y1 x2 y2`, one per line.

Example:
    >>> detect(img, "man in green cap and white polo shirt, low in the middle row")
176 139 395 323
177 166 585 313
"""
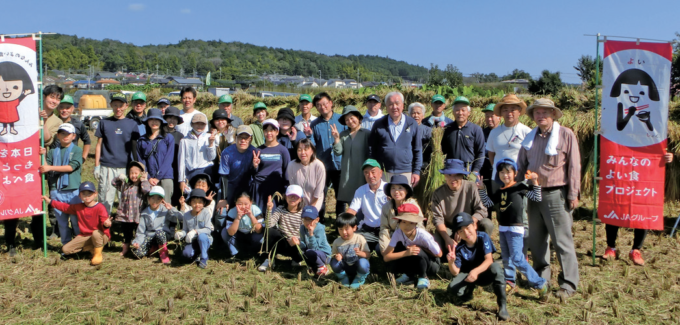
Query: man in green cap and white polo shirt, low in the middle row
347 159 387 252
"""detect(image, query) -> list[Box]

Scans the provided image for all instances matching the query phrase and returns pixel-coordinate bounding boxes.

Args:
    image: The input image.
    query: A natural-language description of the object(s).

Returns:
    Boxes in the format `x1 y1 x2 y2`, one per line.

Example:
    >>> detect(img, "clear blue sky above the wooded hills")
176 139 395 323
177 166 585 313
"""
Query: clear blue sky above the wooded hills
0 0 680 82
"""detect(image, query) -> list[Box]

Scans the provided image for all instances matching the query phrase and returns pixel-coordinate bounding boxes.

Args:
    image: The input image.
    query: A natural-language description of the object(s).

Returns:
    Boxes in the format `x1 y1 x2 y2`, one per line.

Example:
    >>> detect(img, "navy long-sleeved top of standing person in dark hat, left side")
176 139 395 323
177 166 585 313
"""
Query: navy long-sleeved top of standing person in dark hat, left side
137 134 175 180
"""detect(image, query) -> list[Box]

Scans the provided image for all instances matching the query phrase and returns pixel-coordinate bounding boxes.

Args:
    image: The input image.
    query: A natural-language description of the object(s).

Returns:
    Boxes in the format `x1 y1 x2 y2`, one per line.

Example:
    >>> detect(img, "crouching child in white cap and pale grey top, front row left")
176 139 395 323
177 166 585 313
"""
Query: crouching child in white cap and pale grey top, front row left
132 186 182 265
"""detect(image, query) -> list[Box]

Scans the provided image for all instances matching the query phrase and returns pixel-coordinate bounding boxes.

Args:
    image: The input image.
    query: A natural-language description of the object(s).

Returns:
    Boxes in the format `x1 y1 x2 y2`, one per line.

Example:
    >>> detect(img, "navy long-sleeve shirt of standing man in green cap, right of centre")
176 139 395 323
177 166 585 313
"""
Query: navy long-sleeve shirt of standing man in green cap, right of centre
442 121 486 173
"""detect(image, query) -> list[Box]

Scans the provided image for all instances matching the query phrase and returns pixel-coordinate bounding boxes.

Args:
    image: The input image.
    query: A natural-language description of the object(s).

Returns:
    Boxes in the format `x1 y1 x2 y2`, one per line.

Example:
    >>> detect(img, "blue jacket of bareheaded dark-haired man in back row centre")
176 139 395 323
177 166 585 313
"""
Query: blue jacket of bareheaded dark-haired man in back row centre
309 113 347 171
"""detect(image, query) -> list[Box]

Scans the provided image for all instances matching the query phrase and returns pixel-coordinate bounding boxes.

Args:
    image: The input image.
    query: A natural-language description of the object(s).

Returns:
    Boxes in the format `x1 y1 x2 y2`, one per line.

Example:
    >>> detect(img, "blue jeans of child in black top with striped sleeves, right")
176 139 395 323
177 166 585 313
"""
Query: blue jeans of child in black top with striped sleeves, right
500 231 546 289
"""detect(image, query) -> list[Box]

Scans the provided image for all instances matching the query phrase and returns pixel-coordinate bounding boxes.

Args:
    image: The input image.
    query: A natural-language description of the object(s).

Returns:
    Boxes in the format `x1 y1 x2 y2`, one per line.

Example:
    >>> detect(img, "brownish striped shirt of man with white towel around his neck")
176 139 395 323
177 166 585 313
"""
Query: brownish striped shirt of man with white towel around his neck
517 126 581 201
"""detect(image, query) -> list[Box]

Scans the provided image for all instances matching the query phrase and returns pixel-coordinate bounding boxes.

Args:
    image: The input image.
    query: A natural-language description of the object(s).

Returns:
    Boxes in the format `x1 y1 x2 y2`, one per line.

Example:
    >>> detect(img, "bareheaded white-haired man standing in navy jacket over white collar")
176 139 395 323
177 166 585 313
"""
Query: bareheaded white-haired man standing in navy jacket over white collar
368 91 423 187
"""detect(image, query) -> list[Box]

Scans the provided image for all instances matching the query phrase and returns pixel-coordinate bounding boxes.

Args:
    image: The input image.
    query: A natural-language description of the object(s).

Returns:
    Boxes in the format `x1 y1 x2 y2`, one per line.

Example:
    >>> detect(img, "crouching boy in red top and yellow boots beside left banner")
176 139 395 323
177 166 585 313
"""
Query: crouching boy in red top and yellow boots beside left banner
43 182 111 265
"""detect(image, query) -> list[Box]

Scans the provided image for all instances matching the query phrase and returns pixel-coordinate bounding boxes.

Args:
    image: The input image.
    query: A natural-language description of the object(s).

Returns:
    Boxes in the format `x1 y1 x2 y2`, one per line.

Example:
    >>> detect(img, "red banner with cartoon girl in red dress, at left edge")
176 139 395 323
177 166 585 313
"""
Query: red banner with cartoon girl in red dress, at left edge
0 38 42 220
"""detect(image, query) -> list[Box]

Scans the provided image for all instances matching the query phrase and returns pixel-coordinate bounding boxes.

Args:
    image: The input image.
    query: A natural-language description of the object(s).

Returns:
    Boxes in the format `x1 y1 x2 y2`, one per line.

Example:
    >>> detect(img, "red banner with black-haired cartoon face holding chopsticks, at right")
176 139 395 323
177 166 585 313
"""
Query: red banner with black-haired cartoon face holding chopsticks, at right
597 41 672 230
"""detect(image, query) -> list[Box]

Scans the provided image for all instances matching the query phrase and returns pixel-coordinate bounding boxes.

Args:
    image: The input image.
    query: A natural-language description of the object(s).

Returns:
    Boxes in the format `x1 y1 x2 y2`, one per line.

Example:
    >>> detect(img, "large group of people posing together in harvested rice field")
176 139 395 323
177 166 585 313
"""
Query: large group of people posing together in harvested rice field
5 86 672 319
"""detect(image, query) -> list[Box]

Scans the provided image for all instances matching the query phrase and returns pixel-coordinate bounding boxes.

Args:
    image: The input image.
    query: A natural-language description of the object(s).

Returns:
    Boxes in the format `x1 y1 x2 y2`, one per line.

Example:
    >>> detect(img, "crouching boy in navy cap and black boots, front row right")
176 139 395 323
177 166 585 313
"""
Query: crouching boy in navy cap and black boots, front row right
446 212 510 320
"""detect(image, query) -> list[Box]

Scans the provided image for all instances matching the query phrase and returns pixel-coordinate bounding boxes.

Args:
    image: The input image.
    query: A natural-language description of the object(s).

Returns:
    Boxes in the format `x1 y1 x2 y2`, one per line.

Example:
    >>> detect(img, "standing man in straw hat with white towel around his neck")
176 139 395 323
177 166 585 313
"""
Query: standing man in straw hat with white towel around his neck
517 98 581 300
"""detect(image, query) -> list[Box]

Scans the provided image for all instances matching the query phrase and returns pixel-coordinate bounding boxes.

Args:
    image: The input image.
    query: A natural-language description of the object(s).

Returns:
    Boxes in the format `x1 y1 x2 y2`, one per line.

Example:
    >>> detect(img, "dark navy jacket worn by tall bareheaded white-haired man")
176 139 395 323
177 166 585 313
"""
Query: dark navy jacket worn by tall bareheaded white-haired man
368 115 423 175
